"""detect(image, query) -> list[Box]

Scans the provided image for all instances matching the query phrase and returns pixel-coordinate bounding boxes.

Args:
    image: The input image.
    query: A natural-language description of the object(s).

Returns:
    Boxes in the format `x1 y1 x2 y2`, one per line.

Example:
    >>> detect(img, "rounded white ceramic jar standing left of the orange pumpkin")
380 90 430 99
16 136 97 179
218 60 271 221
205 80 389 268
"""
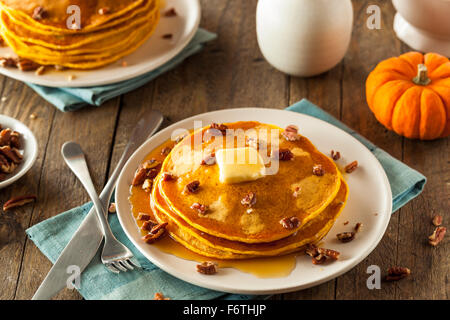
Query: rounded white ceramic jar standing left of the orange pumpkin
256 0 353 77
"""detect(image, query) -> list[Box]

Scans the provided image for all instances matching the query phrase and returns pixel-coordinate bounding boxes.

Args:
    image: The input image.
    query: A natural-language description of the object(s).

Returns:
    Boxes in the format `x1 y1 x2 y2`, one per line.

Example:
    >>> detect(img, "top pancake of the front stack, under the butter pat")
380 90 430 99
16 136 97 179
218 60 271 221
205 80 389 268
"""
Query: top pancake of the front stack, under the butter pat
157 121 341 243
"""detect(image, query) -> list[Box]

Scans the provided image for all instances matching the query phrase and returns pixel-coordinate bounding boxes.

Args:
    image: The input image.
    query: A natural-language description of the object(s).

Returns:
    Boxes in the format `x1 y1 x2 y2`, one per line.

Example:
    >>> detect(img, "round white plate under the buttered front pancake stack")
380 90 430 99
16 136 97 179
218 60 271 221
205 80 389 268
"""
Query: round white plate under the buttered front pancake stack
116 108 392 294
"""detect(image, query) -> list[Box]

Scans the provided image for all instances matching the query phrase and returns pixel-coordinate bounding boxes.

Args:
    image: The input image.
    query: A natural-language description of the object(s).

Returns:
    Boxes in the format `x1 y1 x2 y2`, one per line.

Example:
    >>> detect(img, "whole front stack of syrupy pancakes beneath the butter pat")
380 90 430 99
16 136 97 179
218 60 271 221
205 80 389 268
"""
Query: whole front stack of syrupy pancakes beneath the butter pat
150 122 348 259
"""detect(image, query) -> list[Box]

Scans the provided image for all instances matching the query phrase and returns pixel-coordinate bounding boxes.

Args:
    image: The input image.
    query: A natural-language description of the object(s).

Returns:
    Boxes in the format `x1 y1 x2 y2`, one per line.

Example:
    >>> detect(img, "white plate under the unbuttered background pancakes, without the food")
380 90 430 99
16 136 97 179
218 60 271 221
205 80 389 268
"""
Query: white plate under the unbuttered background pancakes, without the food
0 0 201 87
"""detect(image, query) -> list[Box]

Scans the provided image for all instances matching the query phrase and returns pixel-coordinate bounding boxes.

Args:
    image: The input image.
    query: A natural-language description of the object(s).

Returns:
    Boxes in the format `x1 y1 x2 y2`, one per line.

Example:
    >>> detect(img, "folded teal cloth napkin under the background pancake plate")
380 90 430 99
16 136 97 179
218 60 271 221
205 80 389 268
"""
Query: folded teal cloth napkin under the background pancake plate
27 29 217 111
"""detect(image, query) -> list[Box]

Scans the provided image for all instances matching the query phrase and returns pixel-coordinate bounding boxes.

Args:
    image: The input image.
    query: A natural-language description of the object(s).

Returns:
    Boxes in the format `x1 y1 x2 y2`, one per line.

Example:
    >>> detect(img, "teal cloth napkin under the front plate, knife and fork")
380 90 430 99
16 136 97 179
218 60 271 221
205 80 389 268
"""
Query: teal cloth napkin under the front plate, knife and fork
26 100 426 300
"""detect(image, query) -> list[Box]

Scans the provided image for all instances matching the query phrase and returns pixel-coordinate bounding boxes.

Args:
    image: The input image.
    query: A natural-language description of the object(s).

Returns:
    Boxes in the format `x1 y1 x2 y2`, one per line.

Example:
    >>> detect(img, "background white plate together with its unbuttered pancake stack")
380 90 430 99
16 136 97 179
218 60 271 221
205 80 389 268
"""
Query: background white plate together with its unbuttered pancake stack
0 0 201 87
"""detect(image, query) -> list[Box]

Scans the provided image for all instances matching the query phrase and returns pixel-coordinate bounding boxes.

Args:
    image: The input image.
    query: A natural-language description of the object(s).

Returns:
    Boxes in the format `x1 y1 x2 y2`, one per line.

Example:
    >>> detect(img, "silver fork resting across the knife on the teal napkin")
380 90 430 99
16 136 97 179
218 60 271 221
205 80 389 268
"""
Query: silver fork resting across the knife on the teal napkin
61 142 137 273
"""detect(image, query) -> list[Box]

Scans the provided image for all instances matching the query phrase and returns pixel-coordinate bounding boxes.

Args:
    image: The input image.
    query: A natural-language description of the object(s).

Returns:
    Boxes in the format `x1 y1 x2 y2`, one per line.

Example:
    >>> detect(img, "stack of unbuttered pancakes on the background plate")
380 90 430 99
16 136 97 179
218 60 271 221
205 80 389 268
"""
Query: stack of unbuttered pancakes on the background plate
0 0 160 69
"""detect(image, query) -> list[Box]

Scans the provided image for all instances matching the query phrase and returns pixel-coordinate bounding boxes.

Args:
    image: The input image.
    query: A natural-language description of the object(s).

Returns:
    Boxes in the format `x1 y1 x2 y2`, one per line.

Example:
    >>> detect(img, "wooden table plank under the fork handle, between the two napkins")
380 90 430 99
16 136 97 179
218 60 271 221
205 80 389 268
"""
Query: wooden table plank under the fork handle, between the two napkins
15 99 119 299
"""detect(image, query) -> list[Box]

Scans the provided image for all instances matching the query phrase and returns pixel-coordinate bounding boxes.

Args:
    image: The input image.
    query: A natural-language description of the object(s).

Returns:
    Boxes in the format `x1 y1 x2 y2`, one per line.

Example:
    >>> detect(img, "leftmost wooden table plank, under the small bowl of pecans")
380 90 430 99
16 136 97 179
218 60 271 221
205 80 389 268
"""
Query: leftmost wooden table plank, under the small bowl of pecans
0 76 55 300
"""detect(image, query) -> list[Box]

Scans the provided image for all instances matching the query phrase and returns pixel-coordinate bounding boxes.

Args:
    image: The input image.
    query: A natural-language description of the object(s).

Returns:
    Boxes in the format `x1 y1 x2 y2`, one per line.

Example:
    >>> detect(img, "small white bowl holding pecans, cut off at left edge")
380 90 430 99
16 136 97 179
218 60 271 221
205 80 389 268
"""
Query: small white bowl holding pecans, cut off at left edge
0 114 38 189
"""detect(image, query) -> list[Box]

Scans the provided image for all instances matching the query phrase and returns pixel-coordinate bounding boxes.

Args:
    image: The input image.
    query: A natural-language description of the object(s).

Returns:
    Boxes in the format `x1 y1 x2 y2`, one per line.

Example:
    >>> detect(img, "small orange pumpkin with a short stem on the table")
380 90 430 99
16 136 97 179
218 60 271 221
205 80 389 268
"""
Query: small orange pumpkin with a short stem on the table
366 52 450 140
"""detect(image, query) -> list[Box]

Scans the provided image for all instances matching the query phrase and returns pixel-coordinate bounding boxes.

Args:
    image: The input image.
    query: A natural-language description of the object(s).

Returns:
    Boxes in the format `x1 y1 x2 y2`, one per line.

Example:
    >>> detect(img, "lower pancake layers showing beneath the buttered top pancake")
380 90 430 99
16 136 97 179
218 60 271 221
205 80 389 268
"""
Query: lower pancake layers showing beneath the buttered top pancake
151 175 348 259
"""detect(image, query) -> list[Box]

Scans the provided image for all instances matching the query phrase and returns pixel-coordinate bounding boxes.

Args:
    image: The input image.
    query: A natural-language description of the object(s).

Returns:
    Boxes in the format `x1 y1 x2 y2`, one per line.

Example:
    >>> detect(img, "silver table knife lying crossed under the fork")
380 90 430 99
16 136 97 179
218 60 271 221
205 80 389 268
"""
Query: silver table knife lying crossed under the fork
32 110 164 300
